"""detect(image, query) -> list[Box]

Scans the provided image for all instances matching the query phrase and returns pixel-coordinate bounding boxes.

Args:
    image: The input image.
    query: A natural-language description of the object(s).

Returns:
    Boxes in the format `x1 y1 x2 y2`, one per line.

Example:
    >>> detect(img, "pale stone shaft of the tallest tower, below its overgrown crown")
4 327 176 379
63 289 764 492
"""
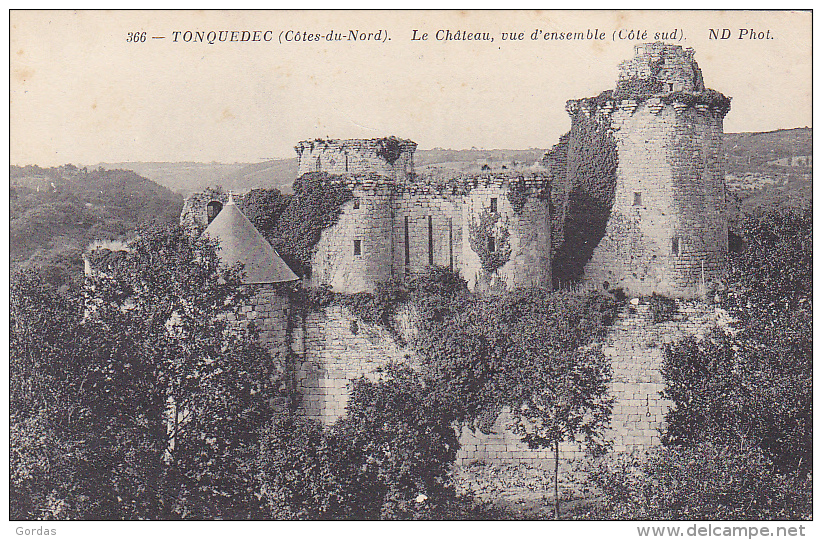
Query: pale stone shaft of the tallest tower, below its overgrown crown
584 98 728 297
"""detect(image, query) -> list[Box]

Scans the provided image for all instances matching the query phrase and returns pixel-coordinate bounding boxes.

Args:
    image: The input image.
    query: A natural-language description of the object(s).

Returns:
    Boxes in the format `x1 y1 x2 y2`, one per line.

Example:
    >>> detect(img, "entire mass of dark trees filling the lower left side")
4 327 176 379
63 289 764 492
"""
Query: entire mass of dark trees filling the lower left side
10 226 278 519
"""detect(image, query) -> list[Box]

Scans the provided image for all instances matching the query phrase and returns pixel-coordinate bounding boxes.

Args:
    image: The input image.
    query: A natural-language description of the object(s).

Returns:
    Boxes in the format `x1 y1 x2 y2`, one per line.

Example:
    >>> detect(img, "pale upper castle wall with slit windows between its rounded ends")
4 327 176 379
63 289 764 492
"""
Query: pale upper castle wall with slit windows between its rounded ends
310 173 551 293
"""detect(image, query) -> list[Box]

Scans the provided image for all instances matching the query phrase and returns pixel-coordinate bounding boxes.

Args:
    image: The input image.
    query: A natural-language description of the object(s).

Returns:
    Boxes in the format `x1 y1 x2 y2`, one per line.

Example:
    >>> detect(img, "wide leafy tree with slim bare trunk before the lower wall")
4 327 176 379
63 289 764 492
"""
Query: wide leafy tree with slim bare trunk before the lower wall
415 280 616 516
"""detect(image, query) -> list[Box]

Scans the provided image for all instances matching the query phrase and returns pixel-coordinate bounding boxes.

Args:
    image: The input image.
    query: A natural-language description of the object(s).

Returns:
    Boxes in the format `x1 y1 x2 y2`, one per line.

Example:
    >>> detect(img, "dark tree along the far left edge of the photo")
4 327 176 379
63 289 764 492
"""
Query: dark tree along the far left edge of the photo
9 271 91 519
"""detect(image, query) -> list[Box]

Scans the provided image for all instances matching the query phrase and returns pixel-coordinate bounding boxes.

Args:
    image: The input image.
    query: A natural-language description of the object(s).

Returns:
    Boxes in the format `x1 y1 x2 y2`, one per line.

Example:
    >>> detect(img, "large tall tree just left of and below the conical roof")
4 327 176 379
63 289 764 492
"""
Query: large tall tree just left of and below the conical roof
79 221 284 518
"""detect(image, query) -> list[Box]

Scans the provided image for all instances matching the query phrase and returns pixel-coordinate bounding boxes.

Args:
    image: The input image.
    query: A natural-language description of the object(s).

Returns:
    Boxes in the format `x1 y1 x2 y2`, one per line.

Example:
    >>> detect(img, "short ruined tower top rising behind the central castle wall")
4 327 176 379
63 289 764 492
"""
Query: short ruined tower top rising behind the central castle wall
294 137 417 182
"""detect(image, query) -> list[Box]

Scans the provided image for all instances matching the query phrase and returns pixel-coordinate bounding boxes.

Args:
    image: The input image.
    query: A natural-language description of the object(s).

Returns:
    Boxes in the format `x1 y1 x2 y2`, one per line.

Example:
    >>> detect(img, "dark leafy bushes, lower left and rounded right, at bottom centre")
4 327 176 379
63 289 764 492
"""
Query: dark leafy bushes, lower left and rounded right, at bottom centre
258 366 458 519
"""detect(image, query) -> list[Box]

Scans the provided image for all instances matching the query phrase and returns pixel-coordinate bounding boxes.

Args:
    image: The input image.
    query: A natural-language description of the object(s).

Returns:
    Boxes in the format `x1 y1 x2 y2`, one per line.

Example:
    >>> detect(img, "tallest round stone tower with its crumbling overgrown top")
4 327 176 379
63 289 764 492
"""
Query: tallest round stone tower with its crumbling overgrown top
566 43 730 297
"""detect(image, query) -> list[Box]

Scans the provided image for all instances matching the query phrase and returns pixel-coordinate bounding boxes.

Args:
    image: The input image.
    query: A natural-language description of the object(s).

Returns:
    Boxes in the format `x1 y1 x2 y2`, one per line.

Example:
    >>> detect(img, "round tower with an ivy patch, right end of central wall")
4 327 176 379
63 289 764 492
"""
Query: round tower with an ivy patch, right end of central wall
460 172 551 292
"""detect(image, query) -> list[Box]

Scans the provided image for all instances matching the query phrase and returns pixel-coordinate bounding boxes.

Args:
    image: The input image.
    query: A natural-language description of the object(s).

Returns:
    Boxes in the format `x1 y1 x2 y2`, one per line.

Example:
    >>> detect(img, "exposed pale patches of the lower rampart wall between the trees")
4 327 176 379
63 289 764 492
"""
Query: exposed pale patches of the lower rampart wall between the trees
294 296 721 466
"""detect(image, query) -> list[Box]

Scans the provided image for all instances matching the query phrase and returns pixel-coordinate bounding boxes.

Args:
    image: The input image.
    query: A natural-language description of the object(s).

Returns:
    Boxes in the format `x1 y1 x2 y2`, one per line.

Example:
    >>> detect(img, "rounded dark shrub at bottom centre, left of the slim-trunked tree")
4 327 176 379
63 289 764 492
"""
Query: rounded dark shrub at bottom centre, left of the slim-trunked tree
334 365 459 519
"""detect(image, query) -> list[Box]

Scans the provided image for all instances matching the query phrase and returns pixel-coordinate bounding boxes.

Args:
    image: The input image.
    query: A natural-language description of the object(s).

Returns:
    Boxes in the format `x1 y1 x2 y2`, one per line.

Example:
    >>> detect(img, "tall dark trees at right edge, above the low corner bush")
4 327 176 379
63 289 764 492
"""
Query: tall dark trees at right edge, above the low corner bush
663 210 813 472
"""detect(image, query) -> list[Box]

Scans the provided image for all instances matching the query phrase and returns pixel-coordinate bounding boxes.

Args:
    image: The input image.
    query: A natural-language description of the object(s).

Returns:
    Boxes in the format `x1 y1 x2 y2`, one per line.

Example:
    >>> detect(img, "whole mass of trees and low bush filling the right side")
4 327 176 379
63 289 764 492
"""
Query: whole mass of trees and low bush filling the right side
592 209 813 519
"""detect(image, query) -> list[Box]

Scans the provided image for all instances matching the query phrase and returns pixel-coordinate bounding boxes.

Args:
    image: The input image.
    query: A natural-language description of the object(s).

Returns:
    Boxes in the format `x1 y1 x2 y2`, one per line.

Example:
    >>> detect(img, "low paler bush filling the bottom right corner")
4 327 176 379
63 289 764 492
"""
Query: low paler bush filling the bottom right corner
586 444 812 520
